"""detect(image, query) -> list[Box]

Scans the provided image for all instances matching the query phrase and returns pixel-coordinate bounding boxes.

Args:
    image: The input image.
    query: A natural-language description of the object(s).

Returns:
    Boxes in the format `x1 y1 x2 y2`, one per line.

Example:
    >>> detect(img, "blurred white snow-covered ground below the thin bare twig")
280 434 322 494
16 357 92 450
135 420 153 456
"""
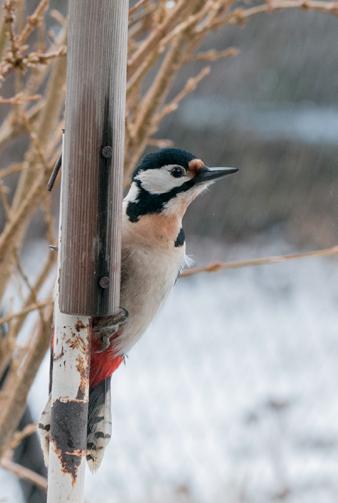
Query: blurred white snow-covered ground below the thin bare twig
0 240 338 503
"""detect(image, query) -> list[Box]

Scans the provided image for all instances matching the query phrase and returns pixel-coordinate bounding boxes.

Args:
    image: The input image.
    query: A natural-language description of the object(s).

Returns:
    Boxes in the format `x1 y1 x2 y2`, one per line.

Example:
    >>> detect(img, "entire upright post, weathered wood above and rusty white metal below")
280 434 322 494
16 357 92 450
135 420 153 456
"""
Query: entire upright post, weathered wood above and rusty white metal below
47 0 128 503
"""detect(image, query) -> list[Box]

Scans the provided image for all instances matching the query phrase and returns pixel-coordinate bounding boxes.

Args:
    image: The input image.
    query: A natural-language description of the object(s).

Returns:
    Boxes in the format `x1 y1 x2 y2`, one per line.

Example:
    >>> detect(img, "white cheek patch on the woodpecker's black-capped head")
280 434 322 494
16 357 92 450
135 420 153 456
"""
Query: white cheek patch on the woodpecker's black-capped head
136 164 189 194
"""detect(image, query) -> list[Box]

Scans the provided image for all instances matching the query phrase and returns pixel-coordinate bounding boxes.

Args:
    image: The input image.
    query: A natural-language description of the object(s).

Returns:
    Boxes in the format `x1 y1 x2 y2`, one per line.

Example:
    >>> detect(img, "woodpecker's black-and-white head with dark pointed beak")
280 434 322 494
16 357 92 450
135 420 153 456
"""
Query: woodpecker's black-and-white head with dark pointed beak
126 148 238 222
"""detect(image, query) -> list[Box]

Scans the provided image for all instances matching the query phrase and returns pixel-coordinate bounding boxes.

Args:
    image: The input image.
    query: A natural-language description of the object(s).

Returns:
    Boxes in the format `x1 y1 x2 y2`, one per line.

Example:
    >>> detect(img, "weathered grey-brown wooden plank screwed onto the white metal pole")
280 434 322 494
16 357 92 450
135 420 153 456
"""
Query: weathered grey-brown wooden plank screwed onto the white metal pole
60 0 128 315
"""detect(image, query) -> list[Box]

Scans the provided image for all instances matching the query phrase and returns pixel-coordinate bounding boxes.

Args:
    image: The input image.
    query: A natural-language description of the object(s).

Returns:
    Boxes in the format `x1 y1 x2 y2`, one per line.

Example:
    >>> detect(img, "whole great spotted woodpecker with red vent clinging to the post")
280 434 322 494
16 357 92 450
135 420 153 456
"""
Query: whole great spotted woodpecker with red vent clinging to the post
39 148 237 470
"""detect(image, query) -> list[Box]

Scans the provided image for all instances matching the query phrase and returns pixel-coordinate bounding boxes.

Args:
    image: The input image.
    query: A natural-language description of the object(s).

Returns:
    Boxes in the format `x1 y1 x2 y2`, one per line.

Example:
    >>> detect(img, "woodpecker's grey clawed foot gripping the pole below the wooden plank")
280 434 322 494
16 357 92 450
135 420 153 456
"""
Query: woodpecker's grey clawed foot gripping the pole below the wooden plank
93 307 128 353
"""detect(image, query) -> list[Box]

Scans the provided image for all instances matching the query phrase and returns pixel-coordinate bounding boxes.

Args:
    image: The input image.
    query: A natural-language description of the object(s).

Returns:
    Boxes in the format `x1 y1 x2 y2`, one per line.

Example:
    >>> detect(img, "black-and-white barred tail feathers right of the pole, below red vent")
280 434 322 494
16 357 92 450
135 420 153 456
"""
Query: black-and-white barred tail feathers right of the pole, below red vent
87 377 112 471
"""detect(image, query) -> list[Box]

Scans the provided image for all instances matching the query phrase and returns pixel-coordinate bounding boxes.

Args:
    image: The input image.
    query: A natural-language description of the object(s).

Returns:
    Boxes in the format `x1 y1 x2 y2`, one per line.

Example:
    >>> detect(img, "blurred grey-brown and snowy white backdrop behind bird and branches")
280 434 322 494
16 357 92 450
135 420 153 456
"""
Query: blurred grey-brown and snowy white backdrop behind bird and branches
0 2 338 503
